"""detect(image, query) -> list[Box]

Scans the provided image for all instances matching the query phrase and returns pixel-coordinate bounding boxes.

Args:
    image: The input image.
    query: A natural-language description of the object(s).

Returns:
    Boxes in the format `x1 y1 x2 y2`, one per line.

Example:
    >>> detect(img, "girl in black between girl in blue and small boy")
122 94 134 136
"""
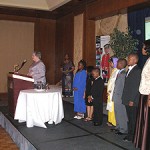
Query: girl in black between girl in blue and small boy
84 66 94 121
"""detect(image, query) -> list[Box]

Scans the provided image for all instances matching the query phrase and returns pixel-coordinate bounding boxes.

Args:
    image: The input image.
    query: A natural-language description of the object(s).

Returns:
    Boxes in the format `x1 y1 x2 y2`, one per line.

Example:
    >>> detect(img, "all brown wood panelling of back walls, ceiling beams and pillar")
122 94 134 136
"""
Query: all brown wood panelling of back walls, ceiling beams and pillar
0 0 149 89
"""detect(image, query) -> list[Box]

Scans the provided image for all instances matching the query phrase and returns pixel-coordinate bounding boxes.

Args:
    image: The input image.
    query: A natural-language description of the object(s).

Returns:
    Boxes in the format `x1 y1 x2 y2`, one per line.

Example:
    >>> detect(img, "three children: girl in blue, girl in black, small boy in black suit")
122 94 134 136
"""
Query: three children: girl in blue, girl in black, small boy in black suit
73 60 104 126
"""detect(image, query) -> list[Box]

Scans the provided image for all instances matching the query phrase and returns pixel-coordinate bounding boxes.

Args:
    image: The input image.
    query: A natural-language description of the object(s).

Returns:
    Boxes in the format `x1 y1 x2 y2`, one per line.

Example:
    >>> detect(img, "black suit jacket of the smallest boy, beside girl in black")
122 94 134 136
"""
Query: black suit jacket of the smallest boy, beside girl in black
91 77 104 103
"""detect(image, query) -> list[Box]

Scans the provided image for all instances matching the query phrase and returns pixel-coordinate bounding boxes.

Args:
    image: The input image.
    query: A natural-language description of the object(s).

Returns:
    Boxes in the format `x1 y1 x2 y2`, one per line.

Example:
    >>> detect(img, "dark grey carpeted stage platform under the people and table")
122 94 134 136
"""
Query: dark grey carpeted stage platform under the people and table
0 101 137 150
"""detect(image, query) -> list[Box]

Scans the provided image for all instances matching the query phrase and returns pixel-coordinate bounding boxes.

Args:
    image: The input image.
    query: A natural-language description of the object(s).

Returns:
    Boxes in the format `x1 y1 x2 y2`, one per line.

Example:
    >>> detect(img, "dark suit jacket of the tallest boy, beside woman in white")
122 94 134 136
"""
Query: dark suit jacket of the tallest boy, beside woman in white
122 65 141 106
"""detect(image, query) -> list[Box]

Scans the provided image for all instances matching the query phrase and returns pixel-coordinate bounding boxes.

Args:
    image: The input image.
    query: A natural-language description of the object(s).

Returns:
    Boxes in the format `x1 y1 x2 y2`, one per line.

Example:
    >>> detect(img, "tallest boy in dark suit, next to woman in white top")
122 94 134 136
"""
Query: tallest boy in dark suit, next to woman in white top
122 53 141 141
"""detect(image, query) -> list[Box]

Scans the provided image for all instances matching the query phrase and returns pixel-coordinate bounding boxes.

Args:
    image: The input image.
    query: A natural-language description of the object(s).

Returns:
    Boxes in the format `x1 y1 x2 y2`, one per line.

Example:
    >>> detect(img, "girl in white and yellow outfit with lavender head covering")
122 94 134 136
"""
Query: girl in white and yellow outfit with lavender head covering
106 57 119 126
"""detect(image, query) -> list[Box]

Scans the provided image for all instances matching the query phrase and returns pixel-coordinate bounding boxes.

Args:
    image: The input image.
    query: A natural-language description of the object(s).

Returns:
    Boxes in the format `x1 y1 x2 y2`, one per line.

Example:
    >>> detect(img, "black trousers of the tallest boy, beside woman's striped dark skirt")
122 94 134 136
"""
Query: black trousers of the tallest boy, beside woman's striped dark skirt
126 106 137 140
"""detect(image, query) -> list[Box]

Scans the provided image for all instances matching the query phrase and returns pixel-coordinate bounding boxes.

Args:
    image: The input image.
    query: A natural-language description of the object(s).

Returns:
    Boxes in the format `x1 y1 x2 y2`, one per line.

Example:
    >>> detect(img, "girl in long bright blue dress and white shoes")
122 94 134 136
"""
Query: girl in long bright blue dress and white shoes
73 60 87 119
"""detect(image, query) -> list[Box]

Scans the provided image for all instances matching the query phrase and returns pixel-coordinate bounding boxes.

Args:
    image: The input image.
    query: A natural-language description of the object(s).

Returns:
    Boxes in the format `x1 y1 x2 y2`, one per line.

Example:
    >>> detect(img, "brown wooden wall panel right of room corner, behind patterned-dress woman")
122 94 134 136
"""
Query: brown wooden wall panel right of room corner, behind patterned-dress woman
55 14 74 82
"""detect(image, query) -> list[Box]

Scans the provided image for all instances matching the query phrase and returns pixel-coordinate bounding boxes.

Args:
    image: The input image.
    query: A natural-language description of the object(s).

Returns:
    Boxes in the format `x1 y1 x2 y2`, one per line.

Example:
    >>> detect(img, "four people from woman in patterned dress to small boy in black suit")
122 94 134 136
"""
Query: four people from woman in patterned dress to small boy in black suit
61 54 104 126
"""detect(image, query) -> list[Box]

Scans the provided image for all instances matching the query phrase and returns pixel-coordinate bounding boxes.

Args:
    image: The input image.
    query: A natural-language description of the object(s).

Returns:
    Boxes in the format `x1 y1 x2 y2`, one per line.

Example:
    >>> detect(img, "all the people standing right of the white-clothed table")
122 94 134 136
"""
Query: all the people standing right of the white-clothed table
62 40 150 150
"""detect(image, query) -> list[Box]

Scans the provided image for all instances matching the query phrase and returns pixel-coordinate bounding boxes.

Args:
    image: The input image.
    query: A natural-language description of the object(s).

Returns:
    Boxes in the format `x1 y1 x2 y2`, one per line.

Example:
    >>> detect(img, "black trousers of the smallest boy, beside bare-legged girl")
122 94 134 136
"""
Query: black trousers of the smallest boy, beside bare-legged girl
93 100 103 125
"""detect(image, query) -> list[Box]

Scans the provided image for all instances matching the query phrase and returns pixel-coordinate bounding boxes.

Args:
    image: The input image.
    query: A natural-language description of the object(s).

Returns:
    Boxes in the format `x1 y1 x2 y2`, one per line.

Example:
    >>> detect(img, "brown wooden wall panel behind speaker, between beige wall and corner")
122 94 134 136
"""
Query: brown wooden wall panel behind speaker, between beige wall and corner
34 19 56 84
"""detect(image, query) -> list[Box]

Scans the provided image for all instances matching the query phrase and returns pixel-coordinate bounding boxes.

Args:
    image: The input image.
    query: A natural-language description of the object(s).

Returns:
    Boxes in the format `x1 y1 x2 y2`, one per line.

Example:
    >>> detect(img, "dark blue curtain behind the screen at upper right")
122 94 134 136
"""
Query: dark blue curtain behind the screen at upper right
128 8 150 68
